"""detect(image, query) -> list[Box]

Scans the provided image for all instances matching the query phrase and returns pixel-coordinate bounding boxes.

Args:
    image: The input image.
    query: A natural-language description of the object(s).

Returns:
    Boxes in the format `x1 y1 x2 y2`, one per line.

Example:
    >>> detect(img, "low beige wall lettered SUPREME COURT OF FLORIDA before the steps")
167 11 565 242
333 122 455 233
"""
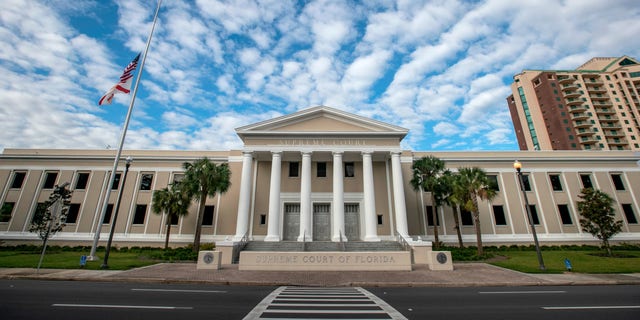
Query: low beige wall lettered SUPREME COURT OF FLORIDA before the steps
238 251 411 271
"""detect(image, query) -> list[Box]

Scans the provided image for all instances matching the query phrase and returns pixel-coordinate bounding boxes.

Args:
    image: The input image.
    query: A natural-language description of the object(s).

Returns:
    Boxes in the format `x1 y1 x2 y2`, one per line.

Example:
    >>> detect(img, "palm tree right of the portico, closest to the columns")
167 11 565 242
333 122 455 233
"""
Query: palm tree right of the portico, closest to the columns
411 156 445 249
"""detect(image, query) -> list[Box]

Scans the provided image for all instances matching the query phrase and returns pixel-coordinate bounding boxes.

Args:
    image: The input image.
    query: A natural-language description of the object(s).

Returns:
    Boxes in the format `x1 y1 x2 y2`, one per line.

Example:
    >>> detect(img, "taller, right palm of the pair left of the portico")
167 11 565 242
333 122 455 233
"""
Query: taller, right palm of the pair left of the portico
182 157 231 252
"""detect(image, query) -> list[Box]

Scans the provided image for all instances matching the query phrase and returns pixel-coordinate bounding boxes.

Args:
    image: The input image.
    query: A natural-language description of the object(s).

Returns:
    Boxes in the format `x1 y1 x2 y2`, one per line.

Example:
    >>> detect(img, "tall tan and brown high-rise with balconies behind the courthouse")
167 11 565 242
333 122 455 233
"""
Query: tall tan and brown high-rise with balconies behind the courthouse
507 56 640 150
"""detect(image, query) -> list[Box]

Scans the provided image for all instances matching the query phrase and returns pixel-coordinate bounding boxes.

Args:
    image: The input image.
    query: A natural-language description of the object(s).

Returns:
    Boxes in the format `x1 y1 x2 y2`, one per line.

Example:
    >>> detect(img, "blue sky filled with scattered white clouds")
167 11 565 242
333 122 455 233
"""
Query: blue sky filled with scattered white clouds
0 0 640 150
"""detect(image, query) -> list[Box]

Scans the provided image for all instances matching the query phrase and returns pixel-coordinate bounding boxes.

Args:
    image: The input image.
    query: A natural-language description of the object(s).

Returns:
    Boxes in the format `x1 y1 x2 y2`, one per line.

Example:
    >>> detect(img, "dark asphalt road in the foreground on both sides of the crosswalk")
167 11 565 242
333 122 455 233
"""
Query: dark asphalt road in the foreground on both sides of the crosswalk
0 280 640 320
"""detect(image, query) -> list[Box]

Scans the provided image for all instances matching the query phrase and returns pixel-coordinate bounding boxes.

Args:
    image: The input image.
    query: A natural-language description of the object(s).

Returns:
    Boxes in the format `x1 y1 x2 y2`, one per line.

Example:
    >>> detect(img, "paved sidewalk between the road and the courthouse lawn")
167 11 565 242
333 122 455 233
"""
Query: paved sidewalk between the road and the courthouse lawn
0 263 640 287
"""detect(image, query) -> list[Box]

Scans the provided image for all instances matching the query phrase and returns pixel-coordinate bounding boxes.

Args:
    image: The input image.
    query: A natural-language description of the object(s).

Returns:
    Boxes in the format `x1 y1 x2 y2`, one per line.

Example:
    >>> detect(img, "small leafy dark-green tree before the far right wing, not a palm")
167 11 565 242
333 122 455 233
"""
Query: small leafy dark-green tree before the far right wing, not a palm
578 188 622 256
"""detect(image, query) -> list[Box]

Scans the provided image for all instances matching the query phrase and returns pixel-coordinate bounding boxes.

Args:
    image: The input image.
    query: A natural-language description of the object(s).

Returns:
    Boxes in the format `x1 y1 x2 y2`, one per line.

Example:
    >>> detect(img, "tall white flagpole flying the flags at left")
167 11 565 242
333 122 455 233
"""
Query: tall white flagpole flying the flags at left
87 0 162 261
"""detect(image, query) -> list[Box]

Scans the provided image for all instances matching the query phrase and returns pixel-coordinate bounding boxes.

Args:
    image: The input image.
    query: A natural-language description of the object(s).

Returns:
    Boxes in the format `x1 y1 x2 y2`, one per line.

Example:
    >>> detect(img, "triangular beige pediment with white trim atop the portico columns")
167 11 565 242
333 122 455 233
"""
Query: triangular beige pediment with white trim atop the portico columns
236 106 408 138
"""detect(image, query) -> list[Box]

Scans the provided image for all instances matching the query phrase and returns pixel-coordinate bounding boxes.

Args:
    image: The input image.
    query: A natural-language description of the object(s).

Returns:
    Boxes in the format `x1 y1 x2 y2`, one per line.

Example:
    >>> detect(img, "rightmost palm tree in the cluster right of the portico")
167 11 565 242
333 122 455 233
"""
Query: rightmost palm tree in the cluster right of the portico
458 167 497 256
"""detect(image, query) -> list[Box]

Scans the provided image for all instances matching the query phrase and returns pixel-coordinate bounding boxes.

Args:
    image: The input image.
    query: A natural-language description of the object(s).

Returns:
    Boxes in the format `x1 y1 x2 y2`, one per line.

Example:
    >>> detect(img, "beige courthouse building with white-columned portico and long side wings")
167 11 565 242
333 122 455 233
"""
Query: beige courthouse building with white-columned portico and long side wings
0 107 640 246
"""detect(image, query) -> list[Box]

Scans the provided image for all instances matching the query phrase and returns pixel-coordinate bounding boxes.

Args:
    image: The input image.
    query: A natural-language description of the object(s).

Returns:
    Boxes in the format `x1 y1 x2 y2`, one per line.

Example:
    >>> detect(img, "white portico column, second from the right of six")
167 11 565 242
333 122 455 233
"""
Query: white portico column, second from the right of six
362 151 380 241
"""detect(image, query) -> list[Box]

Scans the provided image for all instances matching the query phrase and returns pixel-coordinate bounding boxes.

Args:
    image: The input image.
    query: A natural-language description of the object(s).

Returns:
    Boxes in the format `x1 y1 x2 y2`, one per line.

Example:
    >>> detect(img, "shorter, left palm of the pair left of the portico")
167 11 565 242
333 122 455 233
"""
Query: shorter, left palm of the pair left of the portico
151 181 191 250
